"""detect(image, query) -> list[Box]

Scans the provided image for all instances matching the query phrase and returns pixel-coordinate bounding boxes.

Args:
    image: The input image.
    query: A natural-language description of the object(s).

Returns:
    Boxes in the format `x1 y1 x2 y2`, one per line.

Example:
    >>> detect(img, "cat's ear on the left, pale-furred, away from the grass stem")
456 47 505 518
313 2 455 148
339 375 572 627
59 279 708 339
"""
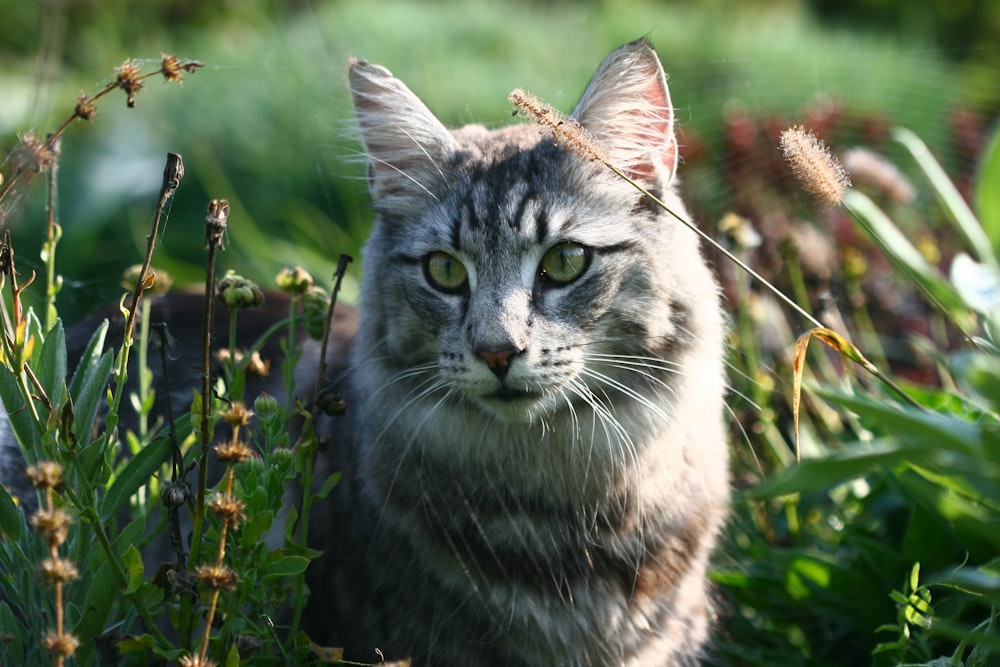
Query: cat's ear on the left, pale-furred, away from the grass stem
348 58 456 213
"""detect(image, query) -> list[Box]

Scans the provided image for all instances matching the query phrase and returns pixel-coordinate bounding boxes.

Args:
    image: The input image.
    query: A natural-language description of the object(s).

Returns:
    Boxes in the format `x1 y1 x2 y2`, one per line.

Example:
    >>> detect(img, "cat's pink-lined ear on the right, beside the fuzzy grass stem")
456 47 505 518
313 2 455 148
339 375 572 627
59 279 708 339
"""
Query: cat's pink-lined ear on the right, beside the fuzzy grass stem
572 39 678 184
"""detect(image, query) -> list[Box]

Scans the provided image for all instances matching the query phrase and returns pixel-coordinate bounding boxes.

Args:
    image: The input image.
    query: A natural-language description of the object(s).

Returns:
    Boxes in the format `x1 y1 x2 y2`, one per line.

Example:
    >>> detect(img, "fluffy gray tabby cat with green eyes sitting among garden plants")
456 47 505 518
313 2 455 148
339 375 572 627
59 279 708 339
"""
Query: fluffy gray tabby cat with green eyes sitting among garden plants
300 41 728 666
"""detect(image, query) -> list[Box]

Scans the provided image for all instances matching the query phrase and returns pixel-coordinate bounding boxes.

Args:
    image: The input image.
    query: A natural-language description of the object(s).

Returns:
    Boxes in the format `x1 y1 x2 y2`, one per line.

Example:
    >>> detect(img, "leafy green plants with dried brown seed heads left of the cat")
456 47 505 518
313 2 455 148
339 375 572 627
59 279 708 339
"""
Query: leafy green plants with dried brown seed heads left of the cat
0 56 346 667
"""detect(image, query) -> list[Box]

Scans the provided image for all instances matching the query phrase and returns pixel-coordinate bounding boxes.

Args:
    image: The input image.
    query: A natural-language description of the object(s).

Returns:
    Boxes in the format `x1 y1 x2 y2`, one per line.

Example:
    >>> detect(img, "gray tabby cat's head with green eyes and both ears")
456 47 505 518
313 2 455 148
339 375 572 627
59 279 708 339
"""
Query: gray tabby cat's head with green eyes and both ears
350 41 721 421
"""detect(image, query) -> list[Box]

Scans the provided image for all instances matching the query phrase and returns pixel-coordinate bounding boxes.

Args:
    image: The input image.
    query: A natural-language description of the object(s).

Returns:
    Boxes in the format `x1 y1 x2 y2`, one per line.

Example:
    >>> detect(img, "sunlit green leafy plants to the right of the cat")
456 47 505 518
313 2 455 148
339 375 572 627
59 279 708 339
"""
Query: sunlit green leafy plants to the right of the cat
714 108 1000 665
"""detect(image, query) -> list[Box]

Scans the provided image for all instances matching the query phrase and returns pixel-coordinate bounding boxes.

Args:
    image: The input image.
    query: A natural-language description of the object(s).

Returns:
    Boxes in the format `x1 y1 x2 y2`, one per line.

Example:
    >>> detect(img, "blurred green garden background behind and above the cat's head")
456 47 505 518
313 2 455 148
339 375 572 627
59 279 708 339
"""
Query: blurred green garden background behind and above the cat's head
0 0 1000 318
